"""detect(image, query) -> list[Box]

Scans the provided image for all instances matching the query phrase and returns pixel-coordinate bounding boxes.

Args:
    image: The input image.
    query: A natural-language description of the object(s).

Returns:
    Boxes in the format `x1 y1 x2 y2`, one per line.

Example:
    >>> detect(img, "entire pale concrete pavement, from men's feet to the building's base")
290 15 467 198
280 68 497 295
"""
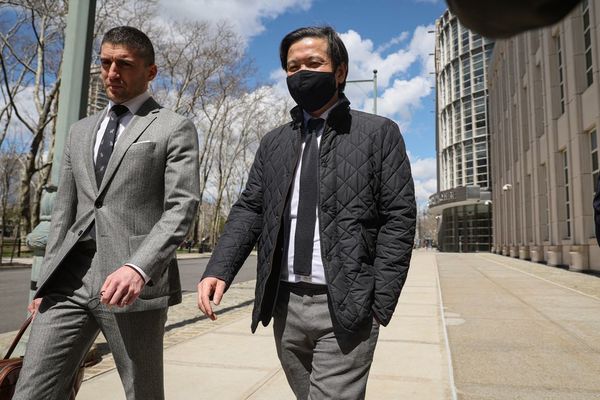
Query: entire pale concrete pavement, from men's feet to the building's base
9 251 600 400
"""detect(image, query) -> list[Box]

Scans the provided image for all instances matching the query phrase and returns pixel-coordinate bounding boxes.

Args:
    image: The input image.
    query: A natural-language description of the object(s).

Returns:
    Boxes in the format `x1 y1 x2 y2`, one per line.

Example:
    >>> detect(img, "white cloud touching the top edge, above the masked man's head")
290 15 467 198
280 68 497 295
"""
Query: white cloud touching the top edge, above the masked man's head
160 0 313 39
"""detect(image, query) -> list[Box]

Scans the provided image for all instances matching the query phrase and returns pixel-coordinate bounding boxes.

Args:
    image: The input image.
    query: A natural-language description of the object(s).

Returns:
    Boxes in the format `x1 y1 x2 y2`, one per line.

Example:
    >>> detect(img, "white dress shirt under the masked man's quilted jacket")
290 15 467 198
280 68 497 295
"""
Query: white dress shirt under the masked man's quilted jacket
281 103 337 285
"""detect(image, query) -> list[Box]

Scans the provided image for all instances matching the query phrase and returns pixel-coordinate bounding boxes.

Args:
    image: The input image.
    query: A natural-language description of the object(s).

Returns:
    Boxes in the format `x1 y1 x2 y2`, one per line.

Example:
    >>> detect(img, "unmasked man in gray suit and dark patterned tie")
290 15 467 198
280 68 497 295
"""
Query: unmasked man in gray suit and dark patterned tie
14 27 199 400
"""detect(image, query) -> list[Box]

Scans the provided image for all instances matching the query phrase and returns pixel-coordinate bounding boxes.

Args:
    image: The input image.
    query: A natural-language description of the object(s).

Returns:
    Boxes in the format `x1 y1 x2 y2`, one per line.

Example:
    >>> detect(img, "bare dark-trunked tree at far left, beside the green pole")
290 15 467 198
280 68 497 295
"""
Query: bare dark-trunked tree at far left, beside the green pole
0 0 66 233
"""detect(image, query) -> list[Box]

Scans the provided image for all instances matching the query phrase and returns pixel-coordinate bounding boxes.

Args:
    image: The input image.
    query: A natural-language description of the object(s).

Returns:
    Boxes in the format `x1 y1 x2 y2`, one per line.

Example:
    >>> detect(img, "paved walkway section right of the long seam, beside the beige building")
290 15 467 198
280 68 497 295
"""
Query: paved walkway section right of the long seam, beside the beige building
437 254 600 400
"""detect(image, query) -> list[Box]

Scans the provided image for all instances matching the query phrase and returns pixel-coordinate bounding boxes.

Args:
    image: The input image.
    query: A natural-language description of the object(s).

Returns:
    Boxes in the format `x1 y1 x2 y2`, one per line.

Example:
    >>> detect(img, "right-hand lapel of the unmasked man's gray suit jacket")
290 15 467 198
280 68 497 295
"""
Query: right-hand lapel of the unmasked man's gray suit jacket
92 98 160 193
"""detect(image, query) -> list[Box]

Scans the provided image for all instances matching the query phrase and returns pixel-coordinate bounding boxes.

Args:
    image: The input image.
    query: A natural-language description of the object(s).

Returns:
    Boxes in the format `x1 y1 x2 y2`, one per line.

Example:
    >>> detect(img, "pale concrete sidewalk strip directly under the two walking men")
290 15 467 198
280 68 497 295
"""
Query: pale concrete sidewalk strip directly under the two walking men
77 251 452 400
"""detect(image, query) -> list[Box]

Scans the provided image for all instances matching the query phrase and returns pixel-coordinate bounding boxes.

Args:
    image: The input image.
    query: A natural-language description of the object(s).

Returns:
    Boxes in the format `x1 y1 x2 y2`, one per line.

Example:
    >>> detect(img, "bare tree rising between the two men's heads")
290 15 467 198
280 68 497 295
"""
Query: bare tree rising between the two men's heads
153 21 254 247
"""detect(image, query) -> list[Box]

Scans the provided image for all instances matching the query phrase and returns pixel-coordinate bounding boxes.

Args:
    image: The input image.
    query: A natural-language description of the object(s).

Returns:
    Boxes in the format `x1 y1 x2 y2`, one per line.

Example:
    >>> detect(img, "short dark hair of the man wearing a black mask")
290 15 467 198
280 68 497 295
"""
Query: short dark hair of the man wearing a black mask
279 26 348 92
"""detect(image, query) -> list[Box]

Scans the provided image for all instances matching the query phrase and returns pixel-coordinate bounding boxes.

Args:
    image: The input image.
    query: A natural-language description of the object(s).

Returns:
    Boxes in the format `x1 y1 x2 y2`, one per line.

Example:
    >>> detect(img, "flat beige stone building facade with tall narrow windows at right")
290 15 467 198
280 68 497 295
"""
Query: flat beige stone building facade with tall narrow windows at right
488 0 600 271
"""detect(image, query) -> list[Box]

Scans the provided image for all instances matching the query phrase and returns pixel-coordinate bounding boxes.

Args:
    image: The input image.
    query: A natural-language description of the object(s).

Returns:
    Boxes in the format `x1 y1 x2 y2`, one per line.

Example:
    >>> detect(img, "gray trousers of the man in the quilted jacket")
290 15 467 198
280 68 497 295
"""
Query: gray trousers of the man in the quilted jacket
273 284 379 400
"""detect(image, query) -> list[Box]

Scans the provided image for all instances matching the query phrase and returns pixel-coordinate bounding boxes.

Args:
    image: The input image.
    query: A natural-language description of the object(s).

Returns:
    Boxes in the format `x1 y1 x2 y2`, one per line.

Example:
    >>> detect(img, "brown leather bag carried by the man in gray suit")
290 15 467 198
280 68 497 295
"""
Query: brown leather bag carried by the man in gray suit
0 316 84 400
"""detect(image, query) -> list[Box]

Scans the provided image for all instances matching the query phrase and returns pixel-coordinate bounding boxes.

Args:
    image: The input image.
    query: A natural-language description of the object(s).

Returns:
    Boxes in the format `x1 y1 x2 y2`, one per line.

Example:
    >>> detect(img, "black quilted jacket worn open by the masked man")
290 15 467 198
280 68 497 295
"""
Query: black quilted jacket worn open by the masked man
204 98 416 332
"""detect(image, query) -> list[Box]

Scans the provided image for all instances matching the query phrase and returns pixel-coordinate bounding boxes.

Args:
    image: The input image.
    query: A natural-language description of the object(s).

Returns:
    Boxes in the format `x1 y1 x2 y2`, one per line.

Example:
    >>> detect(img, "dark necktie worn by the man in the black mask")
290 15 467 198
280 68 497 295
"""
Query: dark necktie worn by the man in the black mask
294 118 325 276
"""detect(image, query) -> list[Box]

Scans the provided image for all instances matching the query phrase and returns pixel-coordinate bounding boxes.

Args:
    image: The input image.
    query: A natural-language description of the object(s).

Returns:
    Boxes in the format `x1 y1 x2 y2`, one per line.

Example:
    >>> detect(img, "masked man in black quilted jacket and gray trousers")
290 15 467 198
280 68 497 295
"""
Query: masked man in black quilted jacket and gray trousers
198 27 416 400
